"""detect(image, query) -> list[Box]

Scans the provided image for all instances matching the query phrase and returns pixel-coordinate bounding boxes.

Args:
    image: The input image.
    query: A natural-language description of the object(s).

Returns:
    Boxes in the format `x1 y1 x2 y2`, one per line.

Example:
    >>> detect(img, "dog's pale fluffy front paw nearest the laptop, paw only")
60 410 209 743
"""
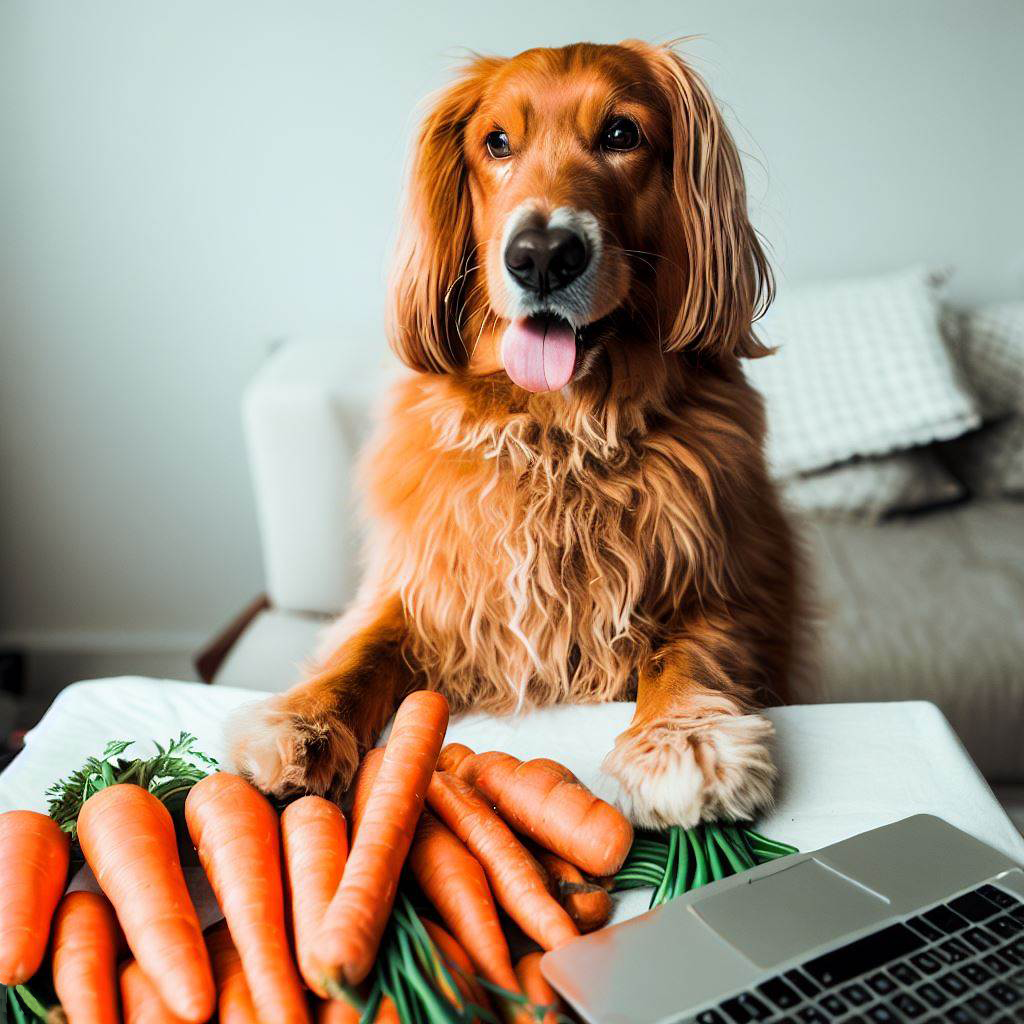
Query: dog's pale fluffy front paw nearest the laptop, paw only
604 714 775 828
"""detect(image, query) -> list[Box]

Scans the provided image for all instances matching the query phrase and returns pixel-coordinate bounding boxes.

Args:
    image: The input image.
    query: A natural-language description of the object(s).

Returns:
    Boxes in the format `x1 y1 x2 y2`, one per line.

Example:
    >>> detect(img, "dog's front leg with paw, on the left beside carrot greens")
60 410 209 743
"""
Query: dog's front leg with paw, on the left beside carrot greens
226 597 420 796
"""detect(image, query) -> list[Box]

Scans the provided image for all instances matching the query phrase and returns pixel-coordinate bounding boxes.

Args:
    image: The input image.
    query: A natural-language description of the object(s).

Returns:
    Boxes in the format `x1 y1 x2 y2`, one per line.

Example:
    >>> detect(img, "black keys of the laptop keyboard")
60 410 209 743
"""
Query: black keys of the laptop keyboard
691 885 1024 1024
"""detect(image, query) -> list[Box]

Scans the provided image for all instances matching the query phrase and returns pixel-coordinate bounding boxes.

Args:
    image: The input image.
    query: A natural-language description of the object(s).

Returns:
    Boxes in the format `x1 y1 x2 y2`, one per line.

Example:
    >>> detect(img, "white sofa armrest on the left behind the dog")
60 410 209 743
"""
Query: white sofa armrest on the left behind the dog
243 339 388 612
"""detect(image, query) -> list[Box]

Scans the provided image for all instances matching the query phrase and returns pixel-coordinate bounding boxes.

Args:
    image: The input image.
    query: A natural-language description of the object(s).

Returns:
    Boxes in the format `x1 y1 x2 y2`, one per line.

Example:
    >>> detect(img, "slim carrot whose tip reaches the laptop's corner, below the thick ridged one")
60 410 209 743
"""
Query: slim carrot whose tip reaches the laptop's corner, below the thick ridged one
427 772 580 949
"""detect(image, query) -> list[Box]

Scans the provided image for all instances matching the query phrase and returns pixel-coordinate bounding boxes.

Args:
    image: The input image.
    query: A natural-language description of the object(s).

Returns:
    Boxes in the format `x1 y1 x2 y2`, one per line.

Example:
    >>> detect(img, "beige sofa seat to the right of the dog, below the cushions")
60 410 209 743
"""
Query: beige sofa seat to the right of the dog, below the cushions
807 501 1024 781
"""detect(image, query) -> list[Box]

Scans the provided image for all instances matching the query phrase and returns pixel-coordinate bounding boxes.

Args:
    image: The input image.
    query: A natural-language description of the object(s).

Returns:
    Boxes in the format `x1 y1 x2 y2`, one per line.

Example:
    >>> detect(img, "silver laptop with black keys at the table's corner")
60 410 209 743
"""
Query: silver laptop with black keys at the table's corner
541 815 1024 1024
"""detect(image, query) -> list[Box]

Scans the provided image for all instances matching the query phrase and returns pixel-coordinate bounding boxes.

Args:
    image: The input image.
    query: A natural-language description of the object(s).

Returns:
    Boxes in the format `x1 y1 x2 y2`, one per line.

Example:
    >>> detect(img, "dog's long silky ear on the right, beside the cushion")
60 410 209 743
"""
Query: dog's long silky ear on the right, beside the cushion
643 46 774 357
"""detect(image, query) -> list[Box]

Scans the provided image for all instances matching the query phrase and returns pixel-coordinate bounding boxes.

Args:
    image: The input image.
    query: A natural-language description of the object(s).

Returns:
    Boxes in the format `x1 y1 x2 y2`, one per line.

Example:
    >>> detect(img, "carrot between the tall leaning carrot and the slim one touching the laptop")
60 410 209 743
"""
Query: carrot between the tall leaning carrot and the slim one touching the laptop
409 811 519 992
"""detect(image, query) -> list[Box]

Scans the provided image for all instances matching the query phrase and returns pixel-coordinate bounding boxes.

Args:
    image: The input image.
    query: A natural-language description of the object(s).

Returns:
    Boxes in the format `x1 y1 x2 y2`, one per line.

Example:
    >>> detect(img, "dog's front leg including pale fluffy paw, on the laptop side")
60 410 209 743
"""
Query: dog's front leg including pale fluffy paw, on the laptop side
605 618 775 828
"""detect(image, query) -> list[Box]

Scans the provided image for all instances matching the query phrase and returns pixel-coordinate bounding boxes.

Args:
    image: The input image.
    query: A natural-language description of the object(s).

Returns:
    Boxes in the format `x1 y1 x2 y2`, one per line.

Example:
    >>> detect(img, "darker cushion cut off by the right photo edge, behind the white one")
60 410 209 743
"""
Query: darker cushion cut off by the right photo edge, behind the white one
944 302 1024 496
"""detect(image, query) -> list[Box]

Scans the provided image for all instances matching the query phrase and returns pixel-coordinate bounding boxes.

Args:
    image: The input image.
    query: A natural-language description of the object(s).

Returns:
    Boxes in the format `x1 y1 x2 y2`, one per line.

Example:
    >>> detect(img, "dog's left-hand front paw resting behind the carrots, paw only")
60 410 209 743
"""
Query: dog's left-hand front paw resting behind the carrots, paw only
225 695 359 797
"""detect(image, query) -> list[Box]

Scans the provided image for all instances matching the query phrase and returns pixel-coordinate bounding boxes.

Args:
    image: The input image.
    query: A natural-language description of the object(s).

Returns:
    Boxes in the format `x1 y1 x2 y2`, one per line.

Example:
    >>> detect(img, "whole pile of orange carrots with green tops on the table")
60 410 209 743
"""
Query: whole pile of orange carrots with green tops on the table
0 691 794 1024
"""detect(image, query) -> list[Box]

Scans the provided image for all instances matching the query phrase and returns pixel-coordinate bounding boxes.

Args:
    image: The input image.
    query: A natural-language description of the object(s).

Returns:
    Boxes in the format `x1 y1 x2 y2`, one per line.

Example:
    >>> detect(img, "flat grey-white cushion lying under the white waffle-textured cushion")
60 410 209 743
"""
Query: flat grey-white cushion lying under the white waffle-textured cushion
782 449 966 522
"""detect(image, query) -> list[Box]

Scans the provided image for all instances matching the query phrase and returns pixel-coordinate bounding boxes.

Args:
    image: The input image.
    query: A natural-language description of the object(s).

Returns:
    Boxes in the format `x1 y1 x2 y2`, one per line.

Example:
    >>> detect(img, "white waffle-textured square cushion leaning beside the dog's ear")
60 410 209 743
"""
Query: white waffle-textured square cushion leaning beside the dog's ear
746 269 980 477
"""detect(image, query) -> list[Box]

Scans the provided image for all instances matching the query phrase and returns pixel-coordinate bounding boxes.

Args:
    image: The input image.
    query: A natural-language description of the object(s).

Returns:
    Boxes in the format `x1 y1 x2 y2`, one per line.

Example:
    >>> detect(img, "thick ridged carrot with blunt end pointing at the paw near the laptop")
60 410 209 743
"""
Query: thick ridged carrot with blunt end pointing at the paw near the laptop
459 751 633 874
